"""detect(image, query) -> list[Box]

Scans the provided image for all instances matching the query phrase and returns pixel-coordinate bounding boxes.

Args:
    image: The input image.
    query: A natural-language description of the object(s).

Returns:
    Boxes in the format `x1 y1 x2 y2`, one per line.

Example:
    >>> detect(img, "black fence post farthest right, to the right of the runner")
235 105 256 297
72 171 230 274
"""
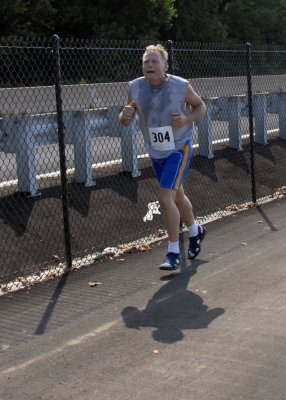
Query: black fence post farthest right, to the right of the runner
245 42 256 203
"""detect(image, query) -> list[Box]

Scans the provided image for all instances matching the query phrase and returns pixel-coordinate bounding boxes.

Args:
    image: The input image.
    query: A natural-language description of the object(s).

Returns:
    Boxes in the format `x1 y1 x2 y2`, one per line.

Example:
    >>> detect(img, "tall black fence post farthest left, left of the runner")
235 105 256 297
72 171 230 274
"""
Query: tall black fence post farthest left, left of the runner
53 35 72 270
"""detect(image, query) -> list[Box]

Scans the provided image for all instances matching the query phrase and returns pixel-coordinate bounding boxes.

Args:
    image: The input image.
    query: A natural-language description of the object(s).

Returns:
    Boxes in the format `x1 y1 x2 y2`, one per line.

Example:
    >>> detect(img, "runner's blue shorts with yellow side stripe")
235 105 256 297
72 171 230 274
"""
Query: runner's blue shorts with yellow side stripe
152 140 192 189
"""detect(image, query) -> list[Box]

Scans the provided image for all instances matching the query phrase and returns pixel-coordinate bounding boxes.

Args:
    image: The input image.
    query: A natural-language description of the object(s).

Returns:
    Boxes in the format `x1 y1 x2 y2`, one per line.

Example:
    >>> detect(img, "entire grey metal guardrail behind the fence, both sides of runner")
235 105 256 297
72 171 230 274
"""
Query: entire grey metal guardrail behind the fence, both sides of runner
0 92 286 195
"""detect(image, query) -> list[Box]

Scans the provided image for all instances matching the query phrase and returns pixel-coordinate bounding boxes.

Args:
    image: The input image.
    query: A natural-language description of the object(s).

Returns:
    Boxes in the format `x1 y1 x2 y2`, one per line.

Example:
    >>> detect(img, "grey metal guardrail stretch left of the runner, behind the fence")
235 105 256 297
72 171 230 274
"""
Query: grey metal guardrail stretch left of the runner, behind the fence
0 106 141 195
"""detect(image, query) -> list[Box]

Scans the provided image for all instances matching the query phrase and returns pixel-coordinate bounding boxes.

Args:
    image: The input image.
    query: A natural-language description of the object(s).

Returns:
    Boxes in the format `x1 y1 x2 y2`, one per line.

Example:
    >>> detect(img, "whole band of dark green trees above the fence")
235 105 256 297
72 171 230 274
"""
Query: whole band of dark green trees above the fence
0 0 286 45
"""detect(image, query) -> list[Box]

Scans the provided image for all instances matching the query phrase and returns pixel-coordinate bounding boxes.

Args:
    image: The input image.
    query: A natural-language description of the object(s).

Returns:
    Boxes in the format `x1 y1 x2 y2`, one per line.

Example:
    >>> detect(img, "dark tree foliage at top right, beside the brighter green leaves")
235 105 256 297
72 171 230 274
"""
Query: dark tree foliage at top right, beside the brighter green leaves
165 0 286 45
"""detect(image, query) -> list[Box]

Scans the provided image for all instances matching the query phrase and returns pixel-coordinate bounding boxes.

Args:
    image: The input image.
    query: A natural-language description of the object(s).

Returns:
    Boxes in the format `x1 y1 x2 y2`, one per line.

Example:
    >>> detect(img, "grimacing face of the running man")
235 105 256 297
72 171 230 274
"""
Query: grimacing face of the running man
142 51 168 83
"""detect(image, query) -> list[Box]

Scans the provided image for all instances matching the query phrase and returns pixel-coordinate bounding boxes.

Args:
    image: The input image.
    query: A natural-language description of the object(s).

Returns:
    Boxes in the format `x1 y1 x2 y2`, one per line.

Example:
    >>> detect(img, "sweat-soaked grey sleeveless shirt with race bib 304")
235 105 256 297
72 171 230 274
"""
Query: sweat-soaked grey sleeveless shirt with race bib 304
129 74 194 159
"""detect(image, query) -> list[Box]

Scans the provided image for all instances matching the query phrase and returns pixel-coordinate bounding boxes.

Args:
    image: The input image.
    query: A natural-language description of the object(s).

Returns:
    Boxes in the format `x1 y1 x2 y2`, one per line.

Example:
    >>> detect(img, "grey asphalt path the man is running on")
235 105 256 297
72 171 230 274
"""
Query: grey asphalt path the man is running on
0 198 286 400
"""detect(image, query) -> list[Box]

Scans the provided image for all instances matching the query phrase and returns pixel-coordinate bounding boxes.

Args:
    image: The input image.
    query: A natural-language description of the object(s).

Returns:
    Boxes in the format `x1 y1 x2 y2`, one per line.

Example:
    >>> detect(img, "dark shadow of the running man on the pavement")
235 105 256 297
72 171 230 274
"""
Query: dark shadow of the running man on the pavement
121 259 225 344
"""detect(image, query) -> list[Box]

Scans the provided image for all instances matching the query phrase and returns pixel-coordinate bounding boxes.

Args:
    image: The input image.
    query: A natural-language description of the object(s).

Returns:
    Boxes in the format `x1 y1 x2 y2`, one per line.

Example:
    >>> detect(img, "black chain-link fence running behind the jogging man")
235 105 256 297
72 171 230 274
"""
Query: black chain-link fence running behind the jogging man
0 36 286 294
